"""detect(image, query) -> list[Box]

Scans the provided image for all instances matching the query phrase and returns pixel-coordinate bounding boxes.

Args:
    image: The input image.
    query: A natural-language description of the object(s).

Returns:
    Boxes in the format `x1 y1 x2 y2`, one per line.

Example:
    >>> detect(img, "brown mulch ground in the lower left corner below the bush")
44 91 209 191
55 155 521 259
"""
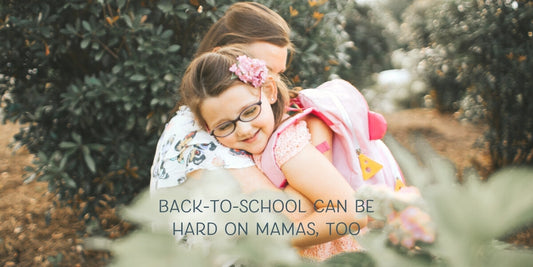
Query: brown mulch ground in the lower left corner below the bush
0 123 120 266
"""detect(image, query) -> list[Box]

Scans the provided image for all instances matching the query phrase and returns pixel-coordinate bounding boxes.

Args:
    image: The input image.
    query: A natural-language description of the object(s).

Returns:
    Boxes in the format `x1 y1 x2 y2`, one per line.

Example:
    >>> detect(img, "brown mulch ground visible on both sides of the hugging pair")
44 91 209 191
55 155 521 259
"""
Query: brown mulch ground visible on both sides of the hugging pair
0 109 533 266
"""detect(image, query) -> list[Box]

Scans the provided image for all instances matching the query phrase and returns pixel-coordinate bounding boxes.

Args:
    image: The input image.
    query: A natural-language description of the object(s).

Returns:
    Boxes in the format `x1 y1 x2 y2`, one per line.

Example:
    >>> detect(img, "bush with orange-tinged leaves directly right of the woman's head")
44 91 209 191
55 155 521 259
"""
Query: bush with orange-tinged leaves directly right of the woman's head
258 0 348 87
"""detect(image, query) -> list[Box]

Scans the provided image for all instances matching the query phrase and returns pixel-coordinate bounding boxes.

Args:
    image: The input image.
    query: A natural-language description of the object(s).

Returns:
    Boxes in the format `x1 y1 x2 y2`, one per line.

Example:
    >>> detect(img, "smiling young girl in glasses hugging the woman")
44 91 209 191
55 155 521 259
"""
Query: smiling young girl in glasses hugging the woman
180 47 366 258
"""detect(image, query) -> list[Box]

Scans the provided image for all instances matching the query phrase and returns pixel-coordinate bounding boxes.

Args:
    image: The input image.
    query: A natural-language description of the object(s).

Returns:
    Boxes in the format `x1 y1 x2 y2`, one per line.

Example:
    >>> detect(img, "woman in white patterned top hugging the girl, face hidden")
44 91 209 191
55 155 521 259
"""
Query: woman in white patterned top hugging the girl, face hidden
150 2 364 260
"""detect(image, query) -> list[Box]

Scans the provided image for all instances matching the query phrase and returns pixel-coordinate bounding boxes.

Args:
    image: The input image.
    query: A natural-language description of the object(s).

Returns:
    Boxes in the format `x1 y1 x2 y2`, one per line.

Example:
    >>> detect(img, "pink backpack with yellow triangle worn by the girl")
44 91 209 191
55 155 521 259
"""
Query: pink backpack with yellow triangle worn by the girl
259 80 405 191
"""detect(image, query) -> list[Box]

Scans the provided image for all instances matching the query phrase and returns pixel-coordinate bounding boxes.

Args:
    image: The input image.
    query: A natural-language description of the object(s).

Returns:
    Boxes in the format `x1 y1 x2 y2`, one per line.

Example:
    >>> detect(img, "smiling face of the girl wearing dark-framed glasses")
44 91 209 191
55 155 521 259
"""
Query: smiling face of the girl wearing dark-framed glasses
200 82 275 154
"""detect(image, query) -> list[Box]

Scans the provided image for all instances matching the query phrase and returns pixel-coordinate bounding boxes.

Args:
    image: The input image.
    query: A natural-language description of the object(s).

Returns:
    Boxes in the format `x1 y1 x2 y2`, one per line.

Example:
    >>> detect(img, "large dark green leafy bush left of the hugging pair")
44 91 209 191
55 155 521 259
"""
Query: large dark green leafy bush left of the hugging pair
0 0 227 224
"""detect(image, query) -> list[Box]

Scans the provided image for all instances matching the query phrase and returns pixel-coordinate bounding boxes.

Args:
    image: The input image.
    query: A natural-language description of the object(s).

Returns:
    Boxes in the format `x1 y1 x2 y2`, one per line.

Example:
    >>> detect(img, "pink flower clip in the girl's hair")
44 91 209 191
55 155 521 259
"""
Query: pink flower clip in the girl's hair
229 55 268 88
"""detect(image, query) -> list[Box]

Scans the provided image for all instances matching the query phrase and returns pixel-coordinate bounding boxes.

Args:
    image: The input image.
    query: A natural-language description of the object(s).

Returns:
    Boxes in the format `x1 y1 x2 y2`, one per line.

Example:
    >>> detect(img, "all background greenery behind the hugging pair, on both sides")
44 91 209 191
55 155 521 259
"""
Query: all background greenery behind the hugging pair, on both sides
0 0 533 266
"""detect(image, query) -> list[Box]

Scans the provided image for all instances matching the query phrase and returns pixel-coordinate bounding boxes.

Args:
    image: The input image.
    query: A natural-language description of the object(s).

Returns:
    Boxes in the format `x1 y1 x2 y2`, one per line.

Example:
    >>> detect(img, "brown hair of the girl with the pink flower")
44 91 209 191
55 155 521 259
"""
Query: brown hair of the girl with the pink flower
180 45 289 131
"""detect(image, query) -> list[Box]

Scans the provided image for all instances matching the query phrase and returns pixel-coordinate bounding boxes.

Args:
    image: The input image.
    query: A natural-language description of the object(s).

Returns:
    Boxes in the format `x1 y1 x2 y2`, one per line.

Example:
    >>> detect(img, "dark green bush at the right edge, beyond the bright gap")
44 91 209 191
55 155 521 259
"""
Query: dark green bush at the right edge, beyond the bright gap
406 0 533 169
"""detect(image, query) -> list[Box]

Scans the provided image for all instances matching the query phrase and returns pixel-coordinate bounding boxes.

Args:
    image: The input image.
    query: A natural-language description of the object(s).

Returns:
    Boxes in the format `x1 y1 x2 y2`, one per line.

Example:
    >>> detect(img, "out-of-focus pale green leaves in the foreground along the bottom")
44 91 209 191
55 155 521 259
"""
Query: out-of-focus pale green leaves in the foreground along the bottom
100 139 533 267
